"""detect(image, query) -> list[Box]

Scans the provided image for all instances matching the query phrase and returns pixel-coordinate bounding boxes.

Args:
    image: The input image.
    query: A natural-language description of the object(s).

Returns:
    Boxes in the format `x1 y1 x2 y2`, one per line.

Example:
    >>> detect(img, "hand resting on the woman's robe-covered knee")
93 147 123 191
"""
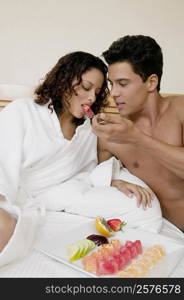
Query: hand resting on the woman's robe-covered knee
111 179 154 209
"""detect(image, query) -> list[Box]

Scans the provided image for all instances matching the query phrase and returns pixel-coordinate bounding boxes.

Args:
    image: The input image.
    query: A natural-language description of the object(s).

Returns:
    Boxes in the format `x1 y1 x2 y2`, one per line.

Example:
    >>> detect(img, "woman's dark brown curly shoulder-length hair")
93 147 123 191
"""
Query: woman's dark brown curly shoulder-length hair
35 51 109 125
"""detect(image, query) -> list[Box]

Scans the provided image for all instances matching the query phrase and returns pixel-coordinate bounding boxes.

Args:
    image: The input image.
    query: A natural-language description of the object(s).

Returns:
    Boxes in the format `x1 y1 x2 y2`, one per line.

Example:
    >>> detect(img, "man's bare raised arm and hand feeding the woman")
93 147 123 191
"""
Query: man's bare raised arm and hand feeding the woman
92 113 184 179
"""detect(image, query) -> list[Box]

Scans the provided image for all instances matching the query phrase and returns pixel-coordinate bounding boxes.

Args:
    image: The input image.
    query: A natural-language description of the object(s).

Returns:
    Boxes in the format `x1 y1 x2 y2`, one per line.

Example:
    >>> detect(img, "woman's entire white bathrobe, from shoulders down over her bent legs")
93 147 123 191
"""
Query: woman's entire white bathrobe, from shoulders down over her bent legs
0 99 162 266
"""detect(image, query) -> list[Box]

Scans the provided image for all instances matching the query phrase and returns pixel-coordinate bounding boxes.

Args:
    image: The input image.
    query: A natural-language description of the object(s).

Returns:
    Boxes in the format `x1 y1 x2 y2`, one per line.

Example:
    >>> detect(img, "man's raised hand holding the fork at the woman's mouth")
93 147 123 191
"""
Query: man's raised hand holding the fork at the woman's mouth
92 113 140 144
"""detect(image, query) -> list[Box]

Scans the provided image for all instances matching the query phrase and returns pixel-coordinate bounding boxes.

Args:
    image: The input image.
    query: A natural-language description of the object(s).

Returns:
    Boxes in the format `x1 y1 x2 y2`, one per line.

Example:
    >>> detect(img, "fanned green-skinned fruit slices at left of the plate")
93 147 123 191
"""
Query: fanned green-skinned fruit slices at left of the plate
67 239 95 261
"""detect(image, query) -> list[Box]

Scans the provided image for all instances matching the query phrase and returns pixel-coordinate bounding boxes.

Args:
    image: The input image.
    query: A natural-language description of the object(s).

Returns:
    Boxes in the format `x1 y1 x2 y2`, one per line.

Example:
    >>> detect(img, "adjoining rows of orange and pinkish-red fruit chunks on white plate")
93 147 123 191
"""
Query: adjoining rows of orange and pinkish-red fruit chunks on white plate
82 239 142 276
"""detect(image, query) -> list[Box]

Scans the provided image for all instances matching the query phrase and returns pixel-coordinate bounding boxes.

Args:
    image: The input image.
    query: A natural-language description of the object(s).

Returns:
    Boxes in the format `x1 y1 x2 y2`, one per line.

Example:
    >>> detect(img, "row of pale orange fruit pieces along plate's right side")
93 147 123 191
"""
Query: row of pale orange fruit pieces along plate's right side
117 245 166 278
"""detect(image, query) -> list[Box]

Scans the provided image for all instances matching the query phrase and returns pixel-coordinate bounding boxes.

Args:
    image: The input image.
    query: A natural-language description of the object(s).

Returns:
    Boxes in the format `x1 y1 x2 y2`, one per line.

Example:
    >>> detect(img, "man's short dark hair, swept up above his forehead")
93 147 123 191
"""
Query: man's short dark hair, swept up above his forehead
102 35 163 91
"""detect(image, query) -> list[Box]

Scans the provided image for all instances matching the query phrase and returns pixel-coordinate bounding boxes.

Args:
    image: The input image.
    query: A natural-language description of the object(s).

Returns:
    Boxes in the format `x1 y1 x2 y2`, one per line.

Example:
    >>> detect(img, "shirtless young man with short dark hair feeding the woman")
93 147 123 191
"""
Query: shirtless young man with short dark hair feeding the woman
93 35 184 231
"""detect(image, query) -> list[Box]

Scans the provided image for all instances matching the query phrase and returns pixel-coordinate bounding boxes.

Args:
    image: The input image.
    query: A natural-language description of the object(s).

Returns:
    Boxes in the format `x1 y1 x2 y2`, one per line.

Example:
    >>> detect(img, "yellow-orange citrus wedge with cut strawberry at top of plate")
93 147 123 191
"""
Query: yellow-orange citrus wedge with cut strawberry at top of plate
95 217 126 237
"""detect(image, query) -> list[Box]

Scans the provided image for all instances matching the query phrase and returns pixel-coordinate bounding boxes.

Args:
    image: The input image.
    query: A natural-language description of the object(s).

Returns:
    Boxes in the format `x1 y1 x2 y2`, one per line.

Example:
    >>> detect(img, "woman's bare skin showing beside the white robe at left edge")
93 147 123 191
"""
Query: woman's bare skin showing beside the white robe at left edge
0 208 17 252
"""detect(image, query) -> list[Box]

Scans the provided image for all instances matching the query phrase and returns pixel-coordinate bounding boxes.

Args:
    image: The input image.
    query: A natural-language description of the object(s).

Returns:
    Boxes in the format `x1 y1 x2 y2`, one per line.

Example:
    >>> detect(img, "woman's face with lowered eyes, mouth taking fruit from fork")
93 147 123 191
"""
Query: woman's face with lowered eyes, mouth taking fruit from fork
63 68 104 118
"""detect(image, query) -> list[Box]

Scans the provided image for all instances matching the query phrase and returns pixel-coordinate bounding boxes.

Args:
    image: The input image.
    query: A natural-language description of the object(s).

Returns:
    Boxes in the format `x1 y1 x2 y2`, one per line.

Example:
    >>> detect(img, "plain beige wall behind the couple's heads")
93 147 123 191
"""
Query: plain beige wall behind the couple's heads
0 0 184 93
